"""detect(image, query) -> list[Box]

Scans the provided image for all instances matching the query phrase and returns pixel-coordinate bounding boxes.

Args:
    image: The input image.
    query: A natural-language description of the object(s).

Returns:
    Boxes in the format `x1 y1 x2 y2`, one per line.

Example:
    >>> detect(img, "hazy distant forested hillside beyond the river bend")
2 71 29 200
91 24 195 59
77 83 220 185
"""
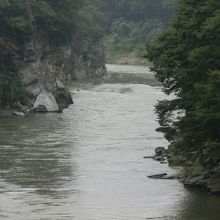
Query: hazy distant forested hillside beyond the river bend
92 0 176 61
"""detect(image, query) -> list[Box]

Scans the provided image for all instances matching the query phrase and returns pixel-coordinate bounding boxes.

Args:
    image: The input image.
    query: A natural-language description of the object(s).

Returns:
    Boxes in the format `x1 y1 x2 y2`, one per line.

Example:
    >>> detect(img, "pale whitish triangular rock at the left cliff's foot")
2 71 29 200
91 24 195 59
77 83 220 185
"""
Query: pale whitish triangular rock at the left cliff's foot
34 90 59 112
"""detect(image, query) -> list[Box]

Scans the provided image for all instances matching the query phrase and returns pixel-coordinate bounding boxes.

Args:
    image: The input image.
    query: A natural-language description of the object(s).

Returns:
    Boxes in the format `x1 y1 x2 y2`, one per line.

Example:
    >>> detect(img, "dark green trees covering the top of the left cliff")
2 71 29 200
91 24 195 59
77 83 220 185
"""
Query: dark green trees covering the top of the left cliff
0 0 103 105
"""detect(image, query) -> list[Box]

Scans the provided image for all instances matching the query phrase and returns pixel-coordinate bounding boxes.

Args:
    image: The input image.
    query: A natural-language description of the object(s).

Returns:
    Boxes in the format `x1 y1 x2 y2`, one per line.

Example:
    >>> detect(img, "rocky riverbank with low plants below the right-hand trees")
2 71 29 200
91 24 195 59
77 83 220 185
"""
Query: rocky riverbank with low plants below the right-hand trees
147 147 220 195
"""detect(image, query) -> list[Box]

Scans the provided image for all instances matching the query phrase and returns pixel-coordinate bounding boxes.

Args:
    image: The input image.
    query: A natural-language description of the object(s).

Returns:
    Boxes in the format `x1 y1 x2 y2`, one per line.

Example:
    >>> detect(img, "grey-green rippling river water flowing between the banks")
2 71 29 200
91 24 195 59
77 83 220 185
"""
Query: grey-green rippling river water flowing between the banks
0 65 220 220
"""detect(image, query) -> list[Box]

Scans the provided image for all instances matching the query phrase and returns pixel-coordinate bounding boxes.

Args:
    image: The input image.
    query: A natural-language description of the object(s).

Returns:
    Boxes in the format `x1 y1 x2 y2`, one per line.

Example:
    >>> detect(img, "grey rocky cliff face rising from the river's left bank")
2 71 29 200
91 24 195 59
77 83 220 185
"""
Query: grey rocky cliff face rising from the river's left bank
17 39 106 112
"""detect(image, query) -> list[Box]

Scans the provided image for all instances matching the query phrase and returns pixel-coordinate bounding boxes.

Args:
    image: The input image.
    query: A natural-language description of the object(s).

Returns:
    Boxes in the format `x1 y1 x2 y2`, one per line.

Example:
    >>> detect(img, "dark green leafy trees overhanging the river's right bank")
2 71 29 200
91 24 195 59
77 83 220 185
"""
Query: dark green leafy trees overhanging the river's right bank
148 0 220 183
